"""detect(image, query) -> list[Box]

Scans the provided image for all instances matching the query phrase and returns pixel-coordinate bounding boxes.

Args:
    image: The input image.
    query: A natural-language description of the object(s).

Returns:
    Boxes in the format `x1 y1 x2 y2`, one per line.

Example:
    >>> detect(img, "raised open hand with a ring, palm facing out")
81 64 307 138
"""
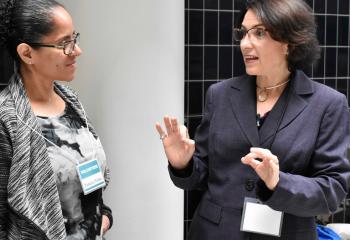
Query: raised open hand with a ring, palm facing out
156 116 195 169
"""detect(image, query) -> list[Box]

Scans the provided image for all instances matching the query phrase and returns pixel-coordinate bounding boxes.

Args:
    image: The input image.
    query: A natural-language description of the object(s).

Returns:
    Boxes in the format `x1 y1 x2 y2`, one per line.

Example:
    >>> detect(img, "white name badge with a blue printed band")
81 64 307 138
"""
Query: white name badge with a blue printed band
77 159 106 195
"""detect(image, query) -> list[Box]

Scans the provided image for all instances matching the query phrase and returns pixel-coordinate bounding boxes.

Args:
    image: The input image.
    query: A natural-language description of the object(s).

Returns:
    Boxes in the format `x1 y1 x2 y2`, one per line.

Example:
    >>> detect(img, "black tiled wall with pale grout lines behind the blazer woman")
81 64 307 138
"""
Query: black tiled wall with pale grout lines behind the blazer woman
184 0 350 236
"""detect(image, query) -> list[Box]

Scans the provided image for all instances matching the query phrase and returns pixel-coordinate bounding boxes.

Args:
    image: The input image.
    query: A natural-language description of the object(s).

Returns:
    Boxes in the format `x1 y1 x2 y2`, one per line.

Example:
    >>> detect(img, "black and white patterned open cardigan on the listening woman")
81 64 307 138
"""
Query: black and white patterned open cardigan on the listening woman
0 74 112 240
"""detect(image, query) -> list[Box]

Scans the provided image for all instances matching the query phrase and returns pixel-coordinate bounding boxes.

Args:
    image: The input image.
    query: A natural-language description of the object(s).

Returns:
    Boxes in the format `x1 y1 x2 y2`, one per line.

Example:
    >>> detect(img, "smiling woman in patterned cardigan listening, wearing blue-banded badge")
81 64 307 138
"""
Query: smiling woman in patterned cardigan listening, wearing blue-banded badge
0 0 113 240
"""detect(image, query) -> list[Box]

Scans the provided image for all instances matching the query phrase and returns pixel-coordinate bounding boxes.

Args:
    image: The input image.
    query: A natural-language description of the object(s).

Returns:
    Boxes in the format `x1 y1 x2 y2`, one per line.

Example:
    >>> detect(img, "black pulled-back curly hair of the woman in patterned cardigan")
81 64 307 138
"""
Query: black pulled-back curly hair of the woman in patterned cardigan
0 0 64 83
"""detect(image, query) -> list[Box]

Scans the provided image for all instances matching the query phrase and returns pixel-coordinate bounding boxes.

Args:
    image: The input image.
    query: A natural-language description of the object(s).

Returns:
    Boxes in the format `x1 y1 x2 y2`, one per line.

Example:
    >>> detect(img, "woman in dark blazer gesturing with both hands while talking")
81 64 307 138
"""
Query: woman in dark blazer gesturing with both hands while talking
156 0 350 240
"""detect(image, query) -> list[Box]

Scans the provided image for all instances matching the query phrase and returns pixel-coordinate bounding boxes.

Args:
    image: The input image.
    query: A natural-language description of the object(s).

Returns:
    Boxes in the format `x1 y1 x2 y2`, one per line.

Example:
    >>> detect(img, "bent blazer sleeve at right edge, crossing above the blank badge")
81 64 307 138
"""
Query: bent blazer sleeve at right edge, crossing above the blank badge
257 94 350 217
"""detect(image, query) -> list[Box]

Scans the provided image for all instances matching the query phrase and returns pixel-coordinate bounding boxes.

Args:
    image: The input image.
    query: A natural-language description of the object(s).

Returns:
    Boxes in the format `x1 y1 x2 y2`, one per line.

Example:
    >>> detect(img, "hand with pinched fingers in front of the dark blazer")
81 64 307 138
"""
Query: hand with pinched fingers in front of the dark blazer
241 147 280 190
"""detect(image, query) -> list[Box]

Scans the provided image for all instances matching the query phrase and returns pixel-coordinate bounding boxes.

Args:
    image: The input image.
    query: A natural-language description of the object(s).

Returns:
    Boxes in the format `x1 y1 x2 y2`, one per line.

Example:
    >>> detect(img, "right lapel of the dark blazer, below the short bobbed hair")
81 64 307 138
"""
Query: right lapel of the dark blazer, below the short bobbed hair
259 71 314 147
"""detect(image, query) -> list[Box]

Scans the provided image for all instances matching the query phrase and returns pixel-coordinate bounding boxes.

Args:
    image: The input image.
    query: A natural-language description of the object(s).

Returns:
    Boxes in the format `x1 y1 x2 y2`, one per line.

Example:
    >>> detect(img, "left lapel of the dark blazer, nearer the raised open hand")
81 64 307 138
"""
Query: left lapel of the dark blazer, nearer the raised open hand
230 75 259 146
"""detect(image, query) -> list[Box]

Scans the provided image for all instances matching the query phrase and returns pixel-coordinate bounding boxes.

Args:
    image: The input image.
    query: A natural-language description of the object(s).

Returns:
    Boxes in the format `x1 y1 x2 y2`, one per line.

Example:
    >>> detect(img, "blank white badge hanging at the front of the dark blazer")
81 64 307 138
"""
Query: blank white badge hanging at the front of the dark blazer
241 198 283 237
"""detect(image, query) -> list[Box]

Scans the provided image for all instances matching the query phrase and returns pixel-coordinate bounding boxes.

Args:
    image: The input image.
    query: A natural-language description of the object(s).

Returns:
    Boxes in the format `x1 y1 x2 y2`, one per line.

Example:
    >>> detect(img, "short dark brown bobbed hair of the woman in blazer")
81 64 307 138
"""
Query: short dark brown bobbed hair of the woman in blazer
239 0 321 71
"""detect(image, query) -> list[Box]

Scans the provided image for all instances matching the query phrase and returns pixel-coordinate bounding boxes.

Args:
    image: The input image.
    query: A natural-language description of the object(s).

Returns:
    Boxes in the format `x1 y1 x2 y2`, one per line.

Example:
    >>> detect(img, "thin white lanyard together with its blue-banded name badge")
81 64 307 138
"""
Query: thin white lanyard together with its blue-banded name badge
16 97 106 195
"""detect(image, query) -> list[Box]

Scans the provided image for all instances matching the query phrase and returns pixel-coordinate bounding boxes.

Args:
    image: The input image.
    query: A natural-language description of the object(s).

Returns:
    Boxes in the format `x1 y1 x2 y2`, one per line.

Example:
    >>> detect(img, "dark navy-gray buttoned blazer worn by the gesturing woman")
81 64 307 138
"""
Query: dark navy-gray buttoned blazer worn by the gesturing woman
169 71 350 240
